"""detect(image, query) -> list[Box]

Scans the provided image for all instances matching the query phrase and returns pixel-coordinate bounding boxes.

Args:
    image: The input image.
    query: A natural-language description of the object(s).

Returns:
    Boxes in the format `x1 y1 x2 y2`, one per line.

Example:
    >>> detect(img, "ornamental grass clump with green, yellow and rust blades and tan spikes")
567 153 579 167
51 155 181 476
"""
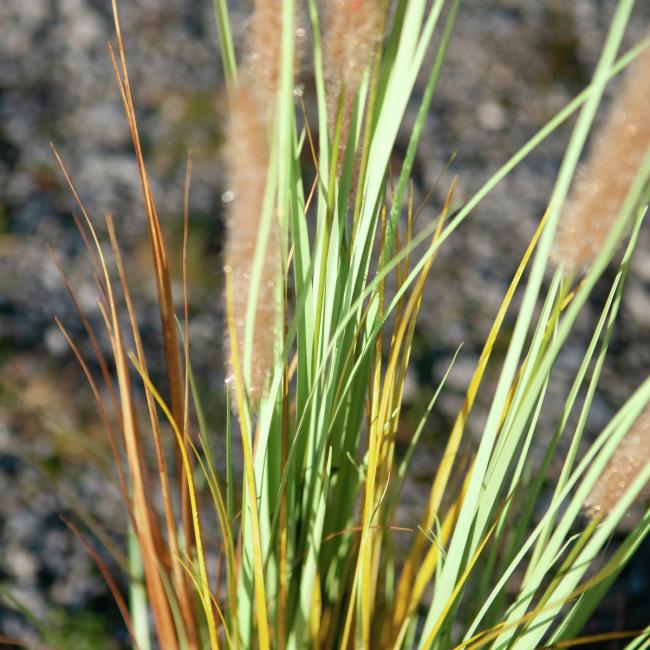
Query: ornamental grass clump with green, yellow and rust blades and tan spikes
39 0 650 650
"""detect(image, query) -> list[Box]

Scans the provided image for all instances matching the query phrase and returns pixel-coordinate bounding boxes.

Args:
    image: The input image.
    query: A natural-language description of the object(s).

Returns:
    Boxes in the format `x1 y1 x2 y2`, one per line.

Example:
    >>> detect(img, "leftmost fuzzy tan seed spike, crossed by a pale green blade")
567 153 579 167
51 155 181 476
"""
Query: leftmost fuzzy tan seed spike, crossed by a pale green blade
225 83 280 401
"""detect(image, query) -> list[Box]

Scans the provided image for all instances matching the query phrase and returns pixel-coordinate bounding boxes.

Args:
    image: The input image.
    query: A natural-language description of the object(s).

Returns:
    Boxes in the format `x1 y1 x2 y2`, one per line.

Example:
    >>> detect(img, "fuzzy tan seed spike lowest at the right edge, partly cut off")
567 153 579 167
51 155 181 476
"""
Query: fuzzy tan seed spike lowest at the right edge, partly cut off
585 406 650 517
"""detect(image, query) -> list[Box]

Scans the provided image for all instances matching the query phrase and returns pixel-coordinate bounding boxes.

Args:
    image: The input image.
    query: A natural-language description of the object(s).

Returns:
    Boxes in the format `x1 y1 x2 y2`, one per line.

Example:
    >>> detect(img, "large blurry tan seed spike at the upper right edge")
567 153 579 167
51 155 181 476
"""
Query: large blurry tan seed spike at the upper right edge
553 48 650 272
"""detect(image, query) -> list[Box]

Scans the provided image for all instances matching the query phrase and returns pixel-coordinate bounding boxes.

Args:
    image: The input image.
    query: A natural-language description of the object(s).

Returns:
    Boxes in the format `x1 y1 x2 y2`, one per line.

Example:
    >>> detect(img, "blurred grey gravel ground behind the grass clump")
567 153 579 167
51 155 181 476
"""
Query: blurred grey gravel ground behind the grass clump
0 0 650 649
